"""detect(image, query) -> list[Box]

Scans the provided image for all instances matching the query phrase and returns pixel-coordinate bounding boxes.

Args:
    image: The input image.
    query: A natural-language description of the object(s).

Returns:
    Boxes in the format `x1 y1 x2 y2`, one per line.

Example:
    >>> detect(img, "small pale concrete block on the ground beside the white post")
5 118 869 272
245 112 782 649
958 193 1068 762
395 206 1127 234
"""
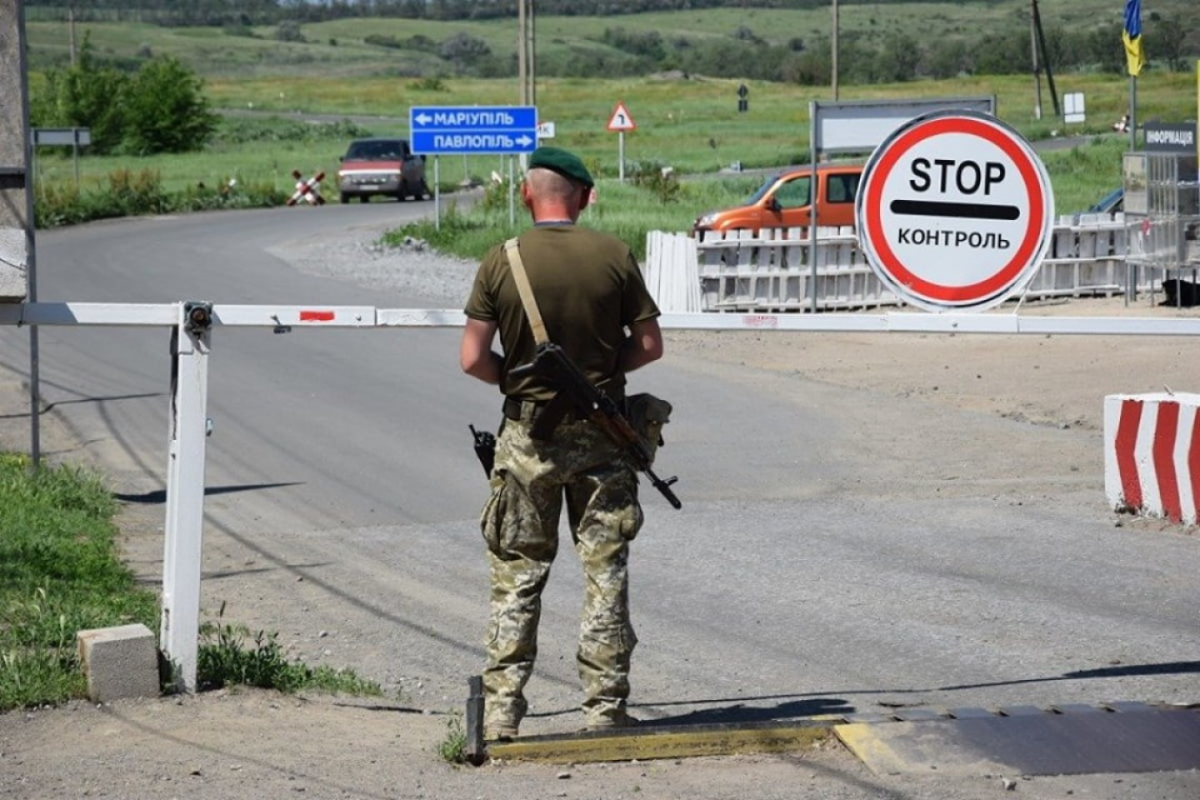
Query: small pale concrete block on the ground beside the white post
76 624 161 703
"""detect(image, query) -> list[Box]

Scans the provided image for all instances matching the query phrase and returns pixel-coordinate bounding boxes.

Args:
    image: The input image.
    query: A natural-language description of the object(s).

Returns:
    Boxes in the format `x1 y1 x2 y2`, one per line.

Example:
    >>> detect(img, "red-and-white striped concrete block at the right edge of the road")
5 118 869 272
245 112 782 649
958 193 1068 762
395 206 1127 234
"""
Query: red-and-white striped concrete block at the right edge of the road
1104 392 1200 525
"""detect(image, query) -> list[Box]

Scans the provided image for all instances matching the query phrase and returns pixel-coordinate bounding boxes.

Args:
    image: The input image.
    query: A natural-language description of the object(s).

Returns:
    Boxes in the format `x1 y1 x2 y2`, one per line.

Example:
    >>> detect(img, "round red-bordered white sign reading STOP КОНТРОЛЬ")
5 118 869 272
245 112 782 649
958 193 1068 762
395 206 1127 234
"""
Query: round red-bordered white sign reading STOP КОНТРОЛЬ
856 110 1054 311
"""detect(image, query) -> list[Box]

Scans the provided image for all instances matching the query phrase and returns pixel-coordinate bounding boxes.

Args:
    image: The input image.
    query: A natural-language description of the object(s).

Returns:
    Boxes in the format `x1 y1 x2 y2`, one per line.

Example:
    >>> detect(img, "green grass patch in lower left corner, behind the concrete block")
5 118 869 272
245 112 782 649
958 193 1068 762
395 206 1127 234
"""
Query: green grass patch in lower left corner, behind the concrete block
0 455 158 710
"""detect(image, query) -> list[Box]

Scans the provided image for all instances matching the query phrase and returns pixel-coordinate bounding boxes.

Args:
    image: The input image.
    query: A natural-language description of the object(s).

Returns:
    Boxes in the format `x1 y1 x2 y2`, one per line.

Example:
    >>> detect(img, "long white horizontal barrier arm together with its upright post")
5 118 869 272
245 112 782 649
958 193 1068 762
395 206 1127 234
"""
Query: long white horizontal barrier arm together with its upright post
0 302 1200 692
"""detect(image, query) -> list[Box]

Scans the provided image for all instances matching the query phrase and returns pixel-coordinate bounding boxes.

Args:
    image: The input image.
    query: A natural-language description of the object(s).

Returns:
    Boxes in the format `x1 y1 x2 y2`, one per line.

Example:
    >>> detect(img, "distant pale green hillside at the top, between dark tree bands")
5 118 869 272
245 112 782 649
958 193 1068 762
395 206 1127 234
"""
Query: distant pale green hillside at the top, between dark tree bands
21 0 1200 78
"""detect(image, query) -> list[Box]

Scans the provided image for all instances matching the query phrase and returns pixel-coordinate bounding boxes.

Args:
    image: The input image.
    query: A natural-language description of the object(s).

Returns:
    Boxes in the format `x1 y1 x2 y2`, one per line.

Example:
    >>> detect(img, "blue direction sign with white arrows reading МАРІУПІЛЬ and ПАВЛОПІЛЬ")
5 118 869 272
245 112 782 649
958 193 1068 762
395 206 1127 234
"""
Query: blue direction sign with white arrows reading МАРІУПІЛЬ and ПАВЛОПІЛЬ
408 106 538 156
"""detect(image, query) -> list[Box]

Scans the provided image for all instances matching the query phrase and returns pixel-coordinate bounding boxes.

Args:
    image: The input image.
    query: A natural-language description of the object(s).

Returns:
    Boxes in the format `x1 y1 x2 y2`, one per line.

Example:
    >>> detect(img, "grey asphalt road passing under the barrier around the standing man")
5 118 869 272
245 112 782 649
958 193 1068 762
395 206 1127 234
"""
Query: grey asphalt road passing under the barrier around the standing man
0 203 1200 800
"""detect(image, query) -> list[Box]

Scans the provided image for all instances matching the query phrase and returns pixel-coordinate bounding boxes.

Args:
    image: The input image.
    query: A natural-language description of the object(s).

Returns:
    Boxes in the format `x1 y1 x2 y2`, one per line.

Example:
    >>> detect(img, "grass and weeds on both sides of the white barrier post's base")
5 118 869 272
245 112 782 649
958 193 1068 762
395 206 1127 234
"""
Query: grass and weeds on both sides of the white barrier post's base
0 453 382 712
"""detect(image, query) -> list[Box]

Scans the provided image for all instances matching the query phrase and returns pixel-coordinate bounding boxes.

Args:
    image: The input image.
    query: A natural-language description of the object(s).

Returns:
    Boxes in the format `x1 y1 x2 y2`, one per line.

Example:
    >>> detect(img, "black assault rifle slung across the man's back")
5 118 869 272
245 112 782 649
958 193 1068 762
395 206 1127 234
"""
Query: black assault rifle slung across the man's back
511 342 683 509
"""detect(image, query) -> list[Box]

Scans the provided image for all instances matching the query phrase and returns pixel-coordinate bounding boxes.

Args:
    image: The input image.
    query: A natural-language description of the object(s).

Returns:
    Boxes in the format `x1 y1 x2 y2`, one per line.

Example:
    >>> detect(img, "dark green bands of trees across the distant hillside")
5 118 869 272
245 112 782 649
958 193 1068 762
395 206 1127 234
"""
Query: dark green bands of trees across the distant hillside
31 0 1200 85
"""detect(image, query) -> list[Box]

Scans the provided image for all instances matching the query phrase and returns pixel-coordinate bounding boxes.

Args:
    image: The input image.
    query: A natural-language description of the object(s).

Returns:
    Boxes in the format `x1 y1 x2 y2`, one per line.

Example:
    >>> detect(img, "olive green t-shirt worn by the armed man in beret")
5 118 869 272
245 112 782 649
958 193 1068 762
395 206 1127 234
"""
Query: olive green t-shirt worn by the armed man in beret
463 224 659 401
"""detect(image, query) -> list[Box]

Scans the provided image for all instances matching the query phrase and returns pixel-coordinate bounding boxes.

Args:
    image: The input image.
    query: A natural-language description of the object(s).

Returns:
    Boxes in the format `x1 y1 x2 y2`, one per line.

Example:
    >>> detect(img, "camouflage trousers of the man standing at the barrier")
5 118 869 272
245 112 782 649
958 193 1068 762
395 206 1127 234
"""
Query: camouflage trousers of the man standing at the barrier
480 410 642 728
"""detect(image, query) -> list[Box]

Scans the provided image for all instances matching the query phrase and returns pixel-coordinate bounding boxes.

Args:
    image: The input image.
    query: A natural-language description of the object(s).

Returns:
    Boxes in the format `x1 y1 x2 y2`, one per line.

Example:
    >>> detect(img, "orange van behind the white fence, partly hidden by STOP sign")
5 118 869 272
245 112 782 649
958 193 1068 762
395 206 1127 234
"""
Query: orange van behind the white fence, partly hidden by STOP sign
692 164 863 233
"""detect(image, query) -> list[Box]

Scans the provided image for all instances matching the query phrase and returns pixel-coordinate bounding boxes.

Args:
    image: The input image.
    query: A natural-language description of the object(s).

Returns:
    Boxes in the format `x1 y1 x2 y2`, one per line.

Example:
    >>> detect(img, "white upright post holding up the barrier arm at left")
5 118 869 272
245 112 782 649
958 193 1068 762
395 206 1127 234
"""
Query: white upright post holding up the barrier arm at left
160 303 212 692
